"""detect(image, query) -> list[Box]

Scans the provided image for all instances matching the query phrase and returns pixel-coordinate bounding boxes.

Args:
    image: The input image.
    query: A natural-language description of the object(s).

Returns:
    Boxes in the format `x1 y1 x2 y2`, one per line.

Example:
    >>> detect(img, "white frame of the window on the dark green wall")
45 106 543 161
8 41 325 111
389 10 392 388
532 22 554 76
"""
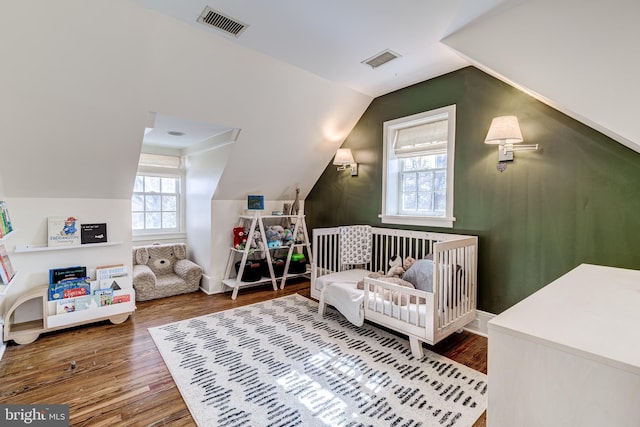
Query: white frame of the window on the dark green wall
380 104 456 228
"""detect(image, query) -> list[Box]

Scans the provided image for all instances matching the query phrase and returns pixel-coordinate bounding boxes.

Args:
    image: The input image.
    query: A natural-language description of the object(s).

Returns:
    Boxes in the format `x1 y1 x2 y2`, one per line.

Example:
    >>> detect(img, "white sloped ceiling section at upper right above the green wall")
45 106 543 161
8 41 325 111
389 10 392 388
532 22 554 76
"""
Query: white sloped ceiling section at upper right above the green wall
443 0 640 151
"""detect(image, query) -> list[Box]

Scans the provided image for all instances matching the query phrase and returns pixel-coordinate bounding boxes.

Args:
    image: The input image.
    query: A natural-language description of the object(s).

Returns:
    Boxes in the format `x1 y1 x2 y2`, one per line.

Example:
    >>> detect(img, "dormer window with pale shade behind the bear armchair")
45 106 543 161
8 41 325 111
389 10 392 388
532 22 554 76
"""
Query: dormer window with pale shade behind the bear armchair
131 153 182 233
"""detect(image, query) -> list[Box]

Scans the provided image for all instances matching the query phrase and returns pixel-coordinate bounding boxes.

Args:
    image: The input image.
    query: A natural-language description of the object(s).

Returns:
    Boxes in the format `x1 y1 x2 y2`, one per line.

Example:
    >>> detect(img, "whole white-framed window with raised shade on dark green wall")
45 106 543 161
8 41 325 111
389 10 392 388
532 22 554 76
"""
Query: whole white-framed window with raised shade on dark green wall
381 105 456 227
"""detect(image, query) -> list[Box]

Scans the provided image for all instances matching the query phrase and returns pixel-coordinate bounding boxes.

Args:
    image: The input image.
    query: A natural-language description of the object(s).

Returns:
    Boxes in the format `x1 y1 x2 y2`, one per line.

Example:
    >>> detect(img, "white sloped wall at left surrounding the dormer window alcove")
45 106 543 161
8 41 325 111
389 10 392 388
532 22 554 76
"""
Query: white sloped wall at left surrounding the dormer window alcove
0 0 371 200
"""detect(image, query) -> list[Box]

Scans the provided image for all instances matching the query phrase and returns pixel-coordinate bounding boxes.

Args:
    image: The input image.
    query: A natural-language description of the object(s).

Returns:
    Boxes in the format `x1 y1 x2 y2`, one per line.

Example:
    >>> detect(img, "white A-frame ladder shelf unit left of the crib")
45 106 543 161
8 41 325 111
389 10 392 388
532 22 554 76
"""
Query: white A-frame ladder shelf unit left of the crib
222 212 312 300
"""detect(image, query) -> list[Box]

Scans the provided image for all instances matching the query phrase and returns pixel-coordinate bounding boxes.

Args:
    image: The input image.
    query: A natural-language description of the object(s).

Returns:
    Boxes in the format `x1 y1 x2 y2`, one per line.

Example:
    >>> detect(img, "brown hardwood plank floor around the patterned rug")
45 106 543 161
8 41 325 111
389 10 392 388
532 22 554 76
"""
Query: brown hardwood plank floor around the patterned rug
0 281 487 427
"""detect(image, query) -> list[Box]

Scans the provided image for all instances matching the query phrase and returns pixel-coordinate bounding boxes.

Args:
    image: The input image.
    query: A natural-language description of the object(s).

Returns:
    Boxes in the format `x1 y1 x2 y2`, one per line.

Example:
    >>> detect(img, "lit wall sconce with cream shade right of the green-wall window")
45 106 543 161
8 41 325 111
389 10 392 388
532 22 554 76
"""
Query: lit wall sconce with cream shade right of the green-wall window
484 116 538 172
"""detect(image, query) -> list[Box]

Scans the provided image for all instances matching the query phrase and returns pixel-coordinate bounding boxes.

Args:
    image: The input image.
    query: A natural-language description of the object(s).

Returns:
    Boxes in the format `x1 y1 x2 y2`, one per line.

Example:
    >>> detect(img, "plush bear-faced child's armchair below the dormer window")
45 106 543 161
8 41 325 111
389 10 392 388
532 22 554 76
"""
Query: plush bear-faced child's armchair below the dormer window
133 243 202 301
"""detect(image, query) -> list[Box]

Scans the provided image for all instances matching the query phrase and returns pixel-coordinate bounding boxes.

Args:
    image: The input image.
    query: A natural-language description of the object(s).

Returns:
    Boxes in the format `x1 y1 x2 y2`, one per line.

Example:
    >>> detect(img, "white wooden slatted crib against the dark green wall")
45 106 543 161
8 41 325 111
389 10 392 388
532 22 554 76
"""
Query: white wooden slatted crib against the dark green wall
311 227 478 358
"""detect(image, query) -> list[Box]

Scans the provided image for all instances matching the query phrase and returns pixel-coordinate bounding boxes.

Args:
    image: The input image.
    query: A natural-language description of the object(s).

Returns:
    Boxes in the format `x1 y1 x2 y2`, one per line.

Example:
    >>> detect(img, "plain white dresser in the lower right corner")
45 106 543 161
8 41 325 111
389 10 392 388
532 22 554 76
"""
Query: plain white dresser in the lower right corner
487 264 640 427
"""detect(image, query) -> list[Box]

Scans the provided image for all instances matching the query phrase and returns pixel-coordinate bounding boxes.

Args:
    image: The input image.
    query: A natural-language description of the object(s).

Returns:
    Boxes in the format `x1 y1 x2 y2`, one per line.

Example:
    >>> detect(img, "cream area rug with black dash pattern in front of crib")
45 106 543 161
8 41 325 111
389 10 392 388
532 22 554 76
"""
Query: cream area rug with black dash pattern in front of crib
149 295 487 427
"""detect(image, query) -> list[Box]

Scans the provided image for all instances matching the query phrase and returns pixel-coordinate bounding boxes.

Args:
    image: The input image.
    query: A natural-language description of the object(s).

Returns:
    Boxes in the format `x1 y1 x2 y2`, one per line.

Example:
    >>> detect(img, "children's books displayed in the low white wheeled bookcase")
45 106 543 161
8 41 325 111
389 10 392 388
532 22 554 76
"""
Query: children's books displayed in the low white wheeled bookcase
48 264 131 314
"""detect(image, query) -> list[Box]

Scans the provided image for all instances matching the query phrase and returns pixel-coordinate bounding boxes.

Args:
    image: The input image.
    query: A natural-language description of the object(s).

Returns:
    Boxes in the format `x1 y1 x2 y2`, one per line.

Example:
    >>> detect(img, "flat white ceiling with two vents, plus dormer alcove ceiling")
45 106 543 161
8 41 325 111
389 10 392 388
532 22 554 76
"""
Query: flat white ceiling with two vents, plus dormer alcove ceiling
132 0 514 148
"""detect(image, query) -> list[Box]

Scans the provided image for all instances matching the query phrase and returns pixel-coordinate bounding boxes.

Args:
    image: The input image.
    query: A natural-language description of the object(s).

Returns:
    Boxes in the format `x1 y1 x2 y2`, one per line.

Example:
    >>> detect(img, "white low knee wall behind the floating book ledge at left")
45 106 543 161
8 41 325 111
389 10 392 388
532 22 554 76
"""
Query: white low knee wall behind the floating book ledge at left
2 198 132 318
